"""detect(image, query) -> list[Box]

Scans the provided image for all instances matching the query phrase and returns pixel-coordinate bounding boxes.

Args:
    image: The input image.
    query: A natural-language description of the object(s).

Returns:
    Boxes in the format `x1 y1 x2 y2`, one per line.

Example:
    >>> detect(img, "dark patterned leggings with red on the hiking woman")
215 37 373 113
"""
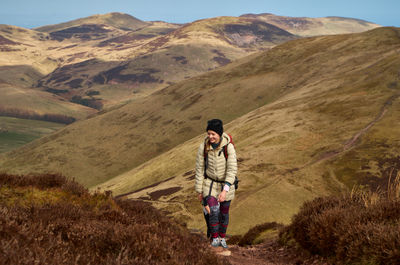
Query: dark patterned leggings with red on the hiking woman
207 196 231 238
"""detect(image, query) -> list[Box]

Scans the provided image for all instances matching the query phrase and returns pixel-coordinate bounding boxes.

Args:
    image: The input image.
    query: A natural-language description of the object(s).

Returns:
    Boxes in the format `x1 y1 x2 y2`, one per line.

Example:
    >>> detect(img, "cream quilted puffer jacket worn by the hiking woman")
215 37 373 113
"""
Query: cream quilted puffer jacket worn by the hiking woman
195 133 237 201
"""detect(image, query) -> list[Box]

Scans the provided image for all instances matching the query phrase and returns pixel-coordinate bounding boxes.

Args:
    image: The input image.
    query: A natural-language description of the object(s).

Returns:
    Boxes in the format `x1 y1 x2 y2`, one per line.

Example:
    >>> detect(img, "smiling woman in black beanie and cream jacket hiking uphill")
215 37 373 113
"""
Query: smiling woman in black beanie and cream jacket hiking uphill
195 119 237 248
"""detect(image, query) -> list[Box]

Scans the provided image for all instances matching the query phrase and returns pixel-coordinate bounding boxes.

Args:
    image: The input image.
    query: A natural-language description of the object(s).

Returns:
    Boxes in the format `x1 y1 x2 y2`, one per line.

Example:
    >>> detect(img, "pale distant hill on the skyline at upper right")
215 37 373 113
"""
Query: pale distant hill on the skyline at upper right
242 14 380 37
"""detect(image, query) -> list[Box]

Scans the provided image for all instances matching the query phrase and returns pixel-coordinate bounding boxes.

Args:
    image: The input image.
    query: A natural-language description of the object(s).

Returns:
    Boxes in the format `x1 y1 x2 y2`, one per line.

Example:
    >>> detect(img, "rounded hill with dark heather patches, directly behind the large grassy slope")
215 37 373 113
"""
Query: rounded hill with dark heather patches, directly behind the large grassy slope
34 14 295 108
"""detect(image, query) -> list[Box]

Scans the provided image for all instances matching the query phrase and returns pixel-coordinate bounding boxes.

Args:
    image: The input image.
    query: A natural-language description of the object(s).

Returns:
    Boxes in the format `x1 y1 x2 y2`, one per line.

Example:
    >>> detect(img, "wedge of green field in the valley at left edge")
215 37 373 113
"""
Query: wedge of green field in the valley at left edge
0 117 64 153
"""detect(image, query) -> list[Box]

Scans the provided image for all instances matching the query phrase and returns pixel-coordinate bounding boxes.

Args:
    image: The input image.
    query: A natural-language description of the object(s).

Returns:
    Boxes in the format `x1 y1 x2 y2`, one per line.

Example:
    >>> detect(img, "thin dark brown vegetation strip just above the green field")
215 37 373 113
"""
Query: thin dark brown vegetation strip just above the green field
0 107 75 124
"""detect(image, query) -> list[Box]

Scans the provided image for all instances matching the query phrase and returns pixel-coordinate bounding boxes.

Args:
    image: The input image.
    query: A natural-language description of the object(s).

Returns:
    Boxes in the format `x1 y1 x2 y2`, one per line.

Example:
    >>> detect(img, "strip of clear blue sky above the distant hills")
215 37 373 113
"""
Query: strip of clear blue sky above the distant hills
0 0 400 28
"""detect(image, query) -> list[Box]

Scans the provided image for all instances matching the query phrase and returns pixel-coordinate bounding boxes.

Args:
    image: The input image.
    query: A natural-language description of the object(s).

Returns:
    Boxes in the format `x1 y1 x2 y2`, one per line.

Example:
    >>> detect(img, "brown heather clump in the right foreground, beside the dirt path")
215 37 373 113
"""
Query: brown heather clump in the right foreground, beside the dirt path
280 176 400 264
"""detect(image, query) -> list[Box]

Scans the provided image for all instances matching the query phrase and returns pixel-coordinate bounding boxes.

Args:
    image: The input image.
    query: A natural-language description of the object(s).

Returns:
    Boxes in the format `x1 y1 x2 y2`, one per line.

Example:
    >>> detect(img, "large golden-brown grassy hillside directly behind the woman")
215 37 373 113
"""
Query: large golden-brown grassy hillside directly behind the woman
0 28 400 233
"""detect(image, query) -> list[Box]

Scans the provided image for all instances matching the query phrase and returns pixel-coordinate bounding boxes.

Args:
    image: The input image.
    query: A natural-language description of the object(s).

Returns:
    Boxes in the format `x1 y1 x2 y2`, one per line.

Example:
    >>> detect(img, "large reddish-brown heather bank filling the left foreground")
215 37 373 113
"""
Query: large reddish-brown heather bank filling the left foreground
0 174 230 264
